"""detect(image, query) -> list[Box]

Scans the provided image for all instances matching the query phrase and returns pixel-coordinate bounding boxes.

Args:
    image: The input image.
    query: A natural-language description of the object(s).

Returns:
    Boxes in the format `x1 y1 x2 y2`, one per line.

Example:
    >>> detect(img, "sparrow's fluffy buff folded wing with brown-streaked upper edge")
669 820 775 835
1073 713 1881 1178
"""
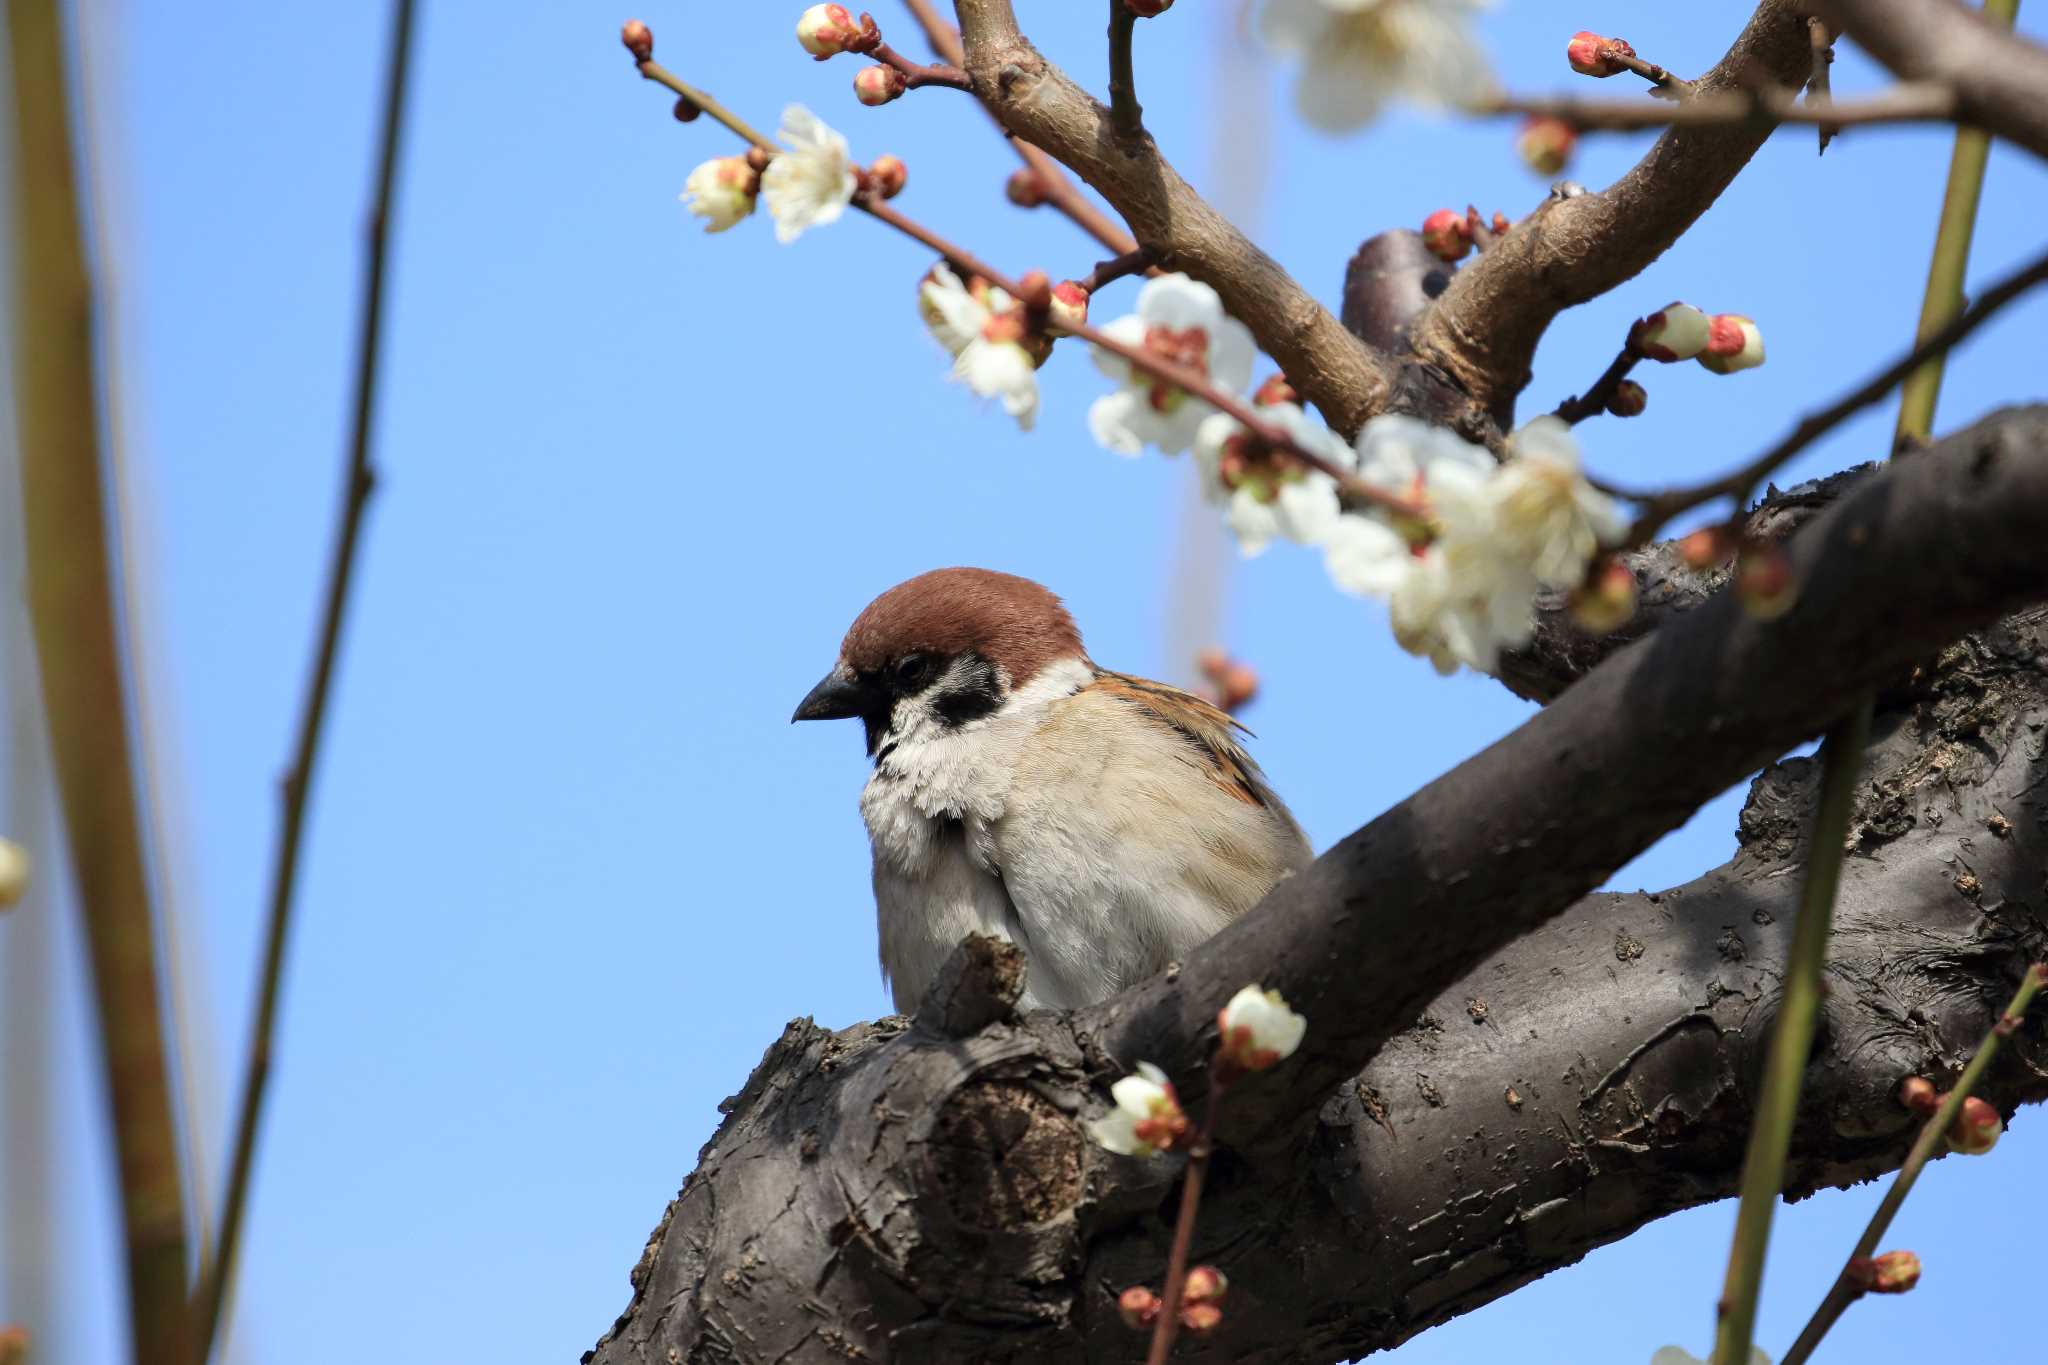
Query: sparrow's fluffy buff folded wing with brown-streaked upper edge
993 673 1311 1005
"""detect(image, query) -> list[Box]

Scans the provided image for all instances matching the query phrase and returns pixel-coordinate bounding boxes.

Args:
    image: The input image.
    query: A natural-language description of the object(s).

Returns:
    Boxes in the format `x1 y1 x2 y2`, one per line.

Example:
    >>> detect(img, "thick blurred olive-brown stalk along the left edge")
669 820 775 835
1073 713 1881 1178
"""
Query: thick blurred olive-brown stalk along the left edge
8 0 190 1365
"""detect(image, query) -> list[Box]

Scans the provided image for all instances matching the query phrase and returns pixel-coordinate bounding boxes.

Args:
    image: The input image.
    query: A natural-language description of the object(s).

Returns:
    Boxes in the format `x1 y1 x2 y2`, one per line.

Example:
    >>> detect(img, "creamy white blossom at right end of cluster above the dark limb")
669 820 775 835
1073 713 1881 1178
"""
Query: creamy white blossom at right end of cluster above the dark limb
1491 415 1628 587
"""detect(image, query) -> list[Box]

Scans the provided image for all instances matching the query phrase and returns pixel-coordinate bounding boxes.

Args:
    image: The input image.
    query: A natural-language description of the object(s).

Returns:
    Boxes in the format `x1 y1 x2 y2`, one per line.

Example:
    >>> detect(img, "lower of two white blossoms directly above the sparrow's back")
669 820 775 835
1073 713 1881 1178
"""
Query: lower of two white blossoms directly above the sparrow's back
1194 403 1358 559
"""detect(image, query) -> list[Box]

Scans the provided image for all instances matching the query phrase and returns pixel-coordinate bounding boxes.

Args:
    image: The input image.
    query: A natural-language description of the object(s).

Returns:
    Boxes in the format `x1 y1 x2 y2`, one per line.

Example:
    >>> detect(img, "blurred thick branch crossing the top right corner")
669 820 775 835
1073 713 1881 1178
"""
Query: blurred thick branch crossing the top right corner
1812 0 2048 158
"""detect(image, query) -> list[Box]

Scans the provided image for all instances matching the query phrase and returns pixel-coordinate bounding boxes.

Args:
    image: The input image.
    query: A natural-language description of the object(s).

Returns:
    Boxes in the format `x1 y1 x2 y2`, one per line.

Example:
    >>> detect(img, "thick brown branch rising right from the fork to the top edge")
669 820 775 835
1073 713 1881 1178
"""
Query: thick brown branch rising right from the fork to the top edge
1413 0 1812 428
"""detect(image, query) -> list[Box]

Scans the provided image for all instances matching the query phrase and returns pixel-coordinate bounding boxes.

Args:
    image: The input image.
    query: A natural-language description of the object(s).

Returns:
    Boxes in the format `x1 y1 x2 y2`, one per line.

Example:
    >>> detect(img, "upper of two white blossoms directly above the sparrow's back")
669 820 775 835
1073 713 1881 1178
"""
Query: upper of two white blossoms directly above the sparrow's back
1087 274 1253 456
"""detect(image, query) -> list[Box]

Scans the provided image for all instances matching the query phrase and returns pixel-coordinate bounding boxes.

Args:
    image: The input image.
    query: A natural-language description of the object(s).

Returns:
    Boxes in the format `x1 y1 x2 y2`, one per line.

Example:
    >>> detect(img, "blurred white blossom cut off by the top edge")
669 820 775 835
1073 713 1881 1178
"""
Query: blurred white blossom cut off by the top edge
1260 0 1495 133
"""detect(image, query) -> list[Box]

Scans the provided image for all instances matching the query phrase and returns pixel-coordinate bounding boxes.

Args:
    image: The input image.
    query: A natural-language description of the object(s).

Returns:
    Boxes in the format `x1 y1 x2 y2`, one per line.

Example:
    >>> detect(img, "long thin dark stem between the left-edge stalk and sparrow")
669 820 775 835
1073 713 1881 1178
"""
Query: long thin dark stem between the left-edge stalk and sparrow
195 0 417 1361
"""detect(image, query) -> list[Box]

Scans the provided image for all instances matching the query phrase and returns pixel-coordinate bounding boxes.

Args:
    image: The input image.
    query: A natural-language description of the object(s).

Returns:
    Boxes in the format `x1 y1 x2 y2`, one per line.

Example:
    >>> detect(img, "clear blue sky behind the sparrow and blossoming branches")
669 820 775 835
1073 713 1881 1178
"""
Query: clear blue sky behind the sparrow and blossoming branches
0 0 2048 1365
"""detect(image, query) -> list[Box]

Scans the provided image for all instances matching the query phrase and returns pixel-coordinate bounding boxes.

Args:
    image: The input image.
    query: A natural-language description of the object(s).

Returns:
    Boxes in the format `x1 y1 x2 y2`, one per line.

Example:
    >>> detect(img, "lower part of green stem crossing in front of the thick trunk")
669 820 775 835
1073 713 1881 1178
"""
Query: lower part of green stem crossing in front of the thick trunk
1714 704 1870 1365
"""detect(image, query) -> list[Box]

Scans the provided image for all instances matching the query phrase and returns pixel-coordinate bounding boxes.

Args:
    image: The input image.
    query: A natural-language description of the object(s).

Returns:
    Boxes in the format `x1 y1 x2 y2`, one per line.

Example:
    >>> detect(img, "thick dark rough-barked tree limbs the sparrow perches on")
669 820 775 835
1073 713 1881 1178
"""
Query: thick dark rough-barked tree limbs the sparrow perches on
586 407 2048 1365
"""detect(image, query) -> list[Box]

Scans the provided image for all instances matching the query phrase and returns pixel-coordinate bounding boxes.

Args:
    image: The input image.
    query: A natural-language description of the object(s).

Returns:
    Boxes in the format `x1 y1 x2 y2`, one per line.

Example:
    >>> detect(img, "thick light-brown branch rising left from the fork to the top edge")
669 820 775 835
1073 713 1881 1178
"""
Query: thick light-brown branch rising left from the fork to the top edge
954 0 1397 434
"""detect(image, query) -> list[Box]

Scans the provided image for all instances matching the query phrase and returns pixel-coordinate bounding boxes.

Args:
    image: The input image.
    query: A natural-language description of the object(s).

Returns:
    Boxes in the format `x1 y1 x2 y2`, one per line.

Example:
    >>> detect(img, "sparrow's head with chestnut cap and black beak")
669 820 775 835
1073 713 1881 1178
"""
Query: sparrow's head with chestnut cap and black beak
791 569 1087 755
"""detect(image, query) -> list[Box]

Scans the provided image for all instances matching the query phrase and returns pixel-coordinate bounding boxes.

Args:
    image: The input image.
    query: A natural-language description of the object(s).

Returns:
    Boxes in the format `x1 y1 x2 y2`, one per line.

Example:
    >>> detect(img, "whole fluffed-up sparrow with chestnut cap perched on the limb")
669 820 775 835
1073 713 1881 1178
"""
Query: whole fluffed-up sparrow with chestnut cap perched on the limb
791 569 1311 1013
